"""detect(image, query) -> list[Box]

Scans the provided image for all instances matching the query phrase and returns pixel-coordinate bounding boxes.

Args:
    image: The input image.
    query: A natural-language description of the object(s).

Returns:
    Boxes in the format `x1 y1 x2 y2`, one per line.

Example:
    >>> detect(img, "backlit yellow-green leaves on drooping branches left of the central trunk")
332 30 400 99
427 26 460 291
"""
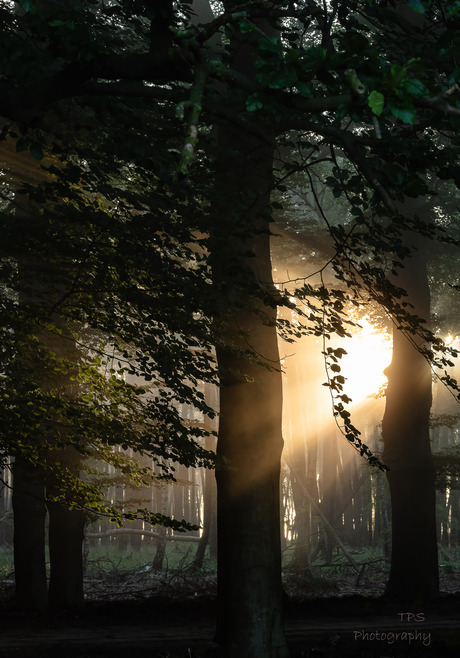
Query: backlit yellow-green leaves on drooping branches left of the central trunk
0 15 216 530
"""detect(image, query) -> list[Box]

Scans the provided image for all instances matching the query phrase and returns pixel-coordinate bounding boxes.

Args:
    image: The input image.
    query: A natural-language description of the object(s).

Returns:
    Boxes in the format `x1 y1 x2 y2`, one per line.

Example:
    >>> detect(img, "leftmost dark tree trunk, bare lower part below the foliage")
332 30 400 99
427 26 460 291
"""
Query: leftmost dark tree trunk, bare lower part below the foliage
13 455 48 610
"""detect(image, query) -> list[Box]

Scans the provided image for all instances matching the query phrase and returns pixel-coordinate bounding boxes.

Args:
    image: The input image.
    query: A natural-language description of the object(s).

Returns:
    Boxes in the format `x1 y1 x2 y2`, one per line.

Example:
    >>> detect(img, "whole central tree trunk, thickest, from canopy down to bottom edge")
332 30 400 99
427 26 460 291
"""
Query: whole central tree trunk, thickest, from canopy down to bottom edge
211 12 288 658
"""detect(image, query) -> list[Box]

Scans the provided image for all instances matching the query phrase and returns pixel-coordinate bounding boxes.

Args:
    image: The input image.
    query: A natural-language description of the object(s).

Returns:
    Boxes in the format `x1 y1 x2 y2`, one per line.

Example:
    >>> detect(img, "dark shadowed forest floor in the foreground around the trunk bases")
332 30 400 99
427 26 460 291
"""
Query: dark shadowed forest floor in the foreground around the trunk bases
0 564 460 658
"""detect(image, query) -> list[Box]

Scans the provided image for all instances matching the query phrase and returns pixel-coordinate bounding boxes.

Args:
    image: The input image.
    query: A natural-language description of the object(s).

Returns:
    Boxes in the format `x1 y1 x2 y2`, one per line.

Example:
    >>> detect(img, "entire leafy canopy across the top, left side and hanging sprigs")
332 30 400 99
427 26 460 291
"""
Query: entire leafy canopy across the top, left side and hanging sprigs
0 0 460 504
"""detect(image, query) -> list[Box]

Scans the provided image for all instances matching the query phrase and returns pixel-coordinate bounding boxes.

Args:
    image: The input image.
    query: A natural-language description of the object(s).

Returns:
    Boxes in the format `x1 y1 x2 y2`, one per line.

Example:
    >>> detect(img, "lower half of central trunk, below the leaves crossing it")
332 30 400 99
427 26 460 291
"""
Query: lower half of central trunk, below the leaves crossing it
216 340 288 658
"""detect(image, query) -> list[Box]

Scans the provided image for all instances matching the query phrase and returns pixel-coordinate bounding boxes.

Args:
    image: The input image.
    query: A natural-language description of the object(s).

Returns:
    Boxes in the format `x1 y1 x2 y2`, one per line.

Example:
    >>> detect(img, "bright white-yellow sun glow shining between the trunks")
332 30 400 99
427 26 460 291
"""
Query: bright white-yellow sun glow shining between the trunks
340 317 392 404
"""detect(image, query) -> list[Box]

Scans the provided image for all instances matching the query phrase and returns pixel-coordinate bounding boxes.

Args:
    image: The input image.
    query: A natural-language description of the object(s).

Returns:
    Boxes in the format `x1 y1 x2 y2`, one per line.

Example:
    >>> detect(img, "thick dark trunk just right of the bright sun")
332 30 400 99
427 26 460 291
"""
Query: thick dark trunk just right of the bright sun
382 235 439 602
